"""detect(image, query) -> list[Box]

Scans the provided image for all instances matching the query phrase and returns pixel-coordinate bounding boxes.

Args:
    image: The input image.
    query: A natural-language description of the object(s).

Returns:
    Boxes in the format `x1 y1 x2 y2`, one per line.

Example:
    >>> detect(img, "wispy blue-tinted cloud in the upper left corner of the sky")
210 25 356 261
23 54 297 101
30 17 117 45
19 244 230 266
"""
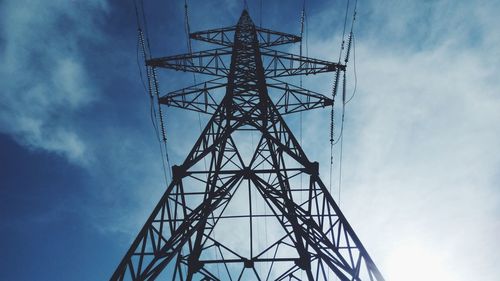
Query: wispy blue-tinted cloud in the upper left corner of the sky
0 0 106 165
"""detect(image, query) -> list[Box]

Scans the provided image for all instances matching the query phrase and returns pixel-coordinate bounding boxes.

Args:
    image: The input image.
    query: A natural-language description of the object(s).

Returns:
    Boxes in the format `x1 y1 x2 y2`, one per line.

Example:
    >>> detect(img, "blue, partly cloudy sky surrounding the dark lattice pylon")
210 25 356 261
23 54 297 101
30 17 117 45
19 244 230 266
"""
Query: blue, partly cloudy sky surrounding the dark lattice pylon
0 0 500 281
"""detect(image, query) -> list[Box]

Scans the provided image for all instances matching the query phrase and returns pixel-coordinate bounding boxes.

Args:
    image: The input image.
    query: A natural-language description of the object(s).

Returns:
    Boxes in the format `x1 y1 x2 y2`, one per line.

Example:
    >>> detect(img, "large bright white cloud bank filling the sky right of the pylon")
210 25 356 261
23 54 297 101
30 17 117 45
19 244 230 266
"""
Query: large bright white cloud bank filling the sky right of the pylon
292 1 500 280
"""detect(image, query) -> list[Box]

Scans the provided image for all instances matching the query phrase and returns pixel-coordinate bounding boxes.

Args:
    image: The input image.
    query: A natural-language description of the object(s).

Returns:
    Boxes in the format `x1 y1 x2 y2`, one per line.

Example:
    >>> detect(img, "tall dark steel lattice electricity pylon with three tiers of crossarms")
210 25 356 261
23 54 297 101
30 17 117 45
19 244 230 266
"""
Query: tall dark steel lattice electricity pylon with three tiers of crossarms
111 10 384 281
